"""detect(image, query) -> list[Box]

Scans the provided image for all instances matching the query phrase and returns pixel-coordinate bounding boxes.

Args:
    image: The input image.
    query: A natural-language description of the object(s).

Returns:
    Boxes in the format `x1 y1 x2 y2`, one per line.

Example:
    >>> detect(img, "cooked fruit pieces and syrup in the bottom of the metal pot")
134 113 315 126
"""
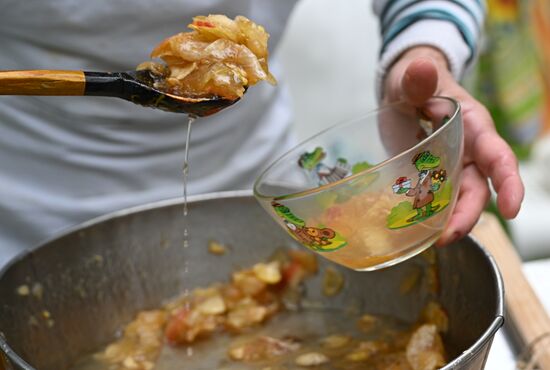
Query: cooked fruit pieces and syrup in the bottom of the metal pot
73 250 448 370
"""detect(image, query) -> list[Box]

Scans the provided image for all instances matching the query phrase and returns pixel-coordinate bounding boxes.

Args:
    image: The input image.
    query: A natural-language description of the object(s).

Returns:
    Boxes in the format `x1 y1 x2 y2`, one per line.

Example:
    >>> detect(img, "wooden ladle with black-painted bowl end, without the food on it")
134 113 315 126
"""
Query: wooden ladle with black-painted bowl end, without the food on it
0 70 243 117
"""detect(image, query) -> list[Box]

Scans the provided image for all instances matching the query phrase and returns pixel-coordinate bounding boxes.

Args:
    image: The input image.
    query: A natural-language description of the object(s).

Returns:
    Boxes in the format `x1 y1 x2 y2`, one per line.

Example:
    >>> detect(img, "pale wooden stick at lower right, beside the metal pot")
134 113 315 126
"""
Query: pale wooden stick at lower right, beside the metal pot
472 214 550 370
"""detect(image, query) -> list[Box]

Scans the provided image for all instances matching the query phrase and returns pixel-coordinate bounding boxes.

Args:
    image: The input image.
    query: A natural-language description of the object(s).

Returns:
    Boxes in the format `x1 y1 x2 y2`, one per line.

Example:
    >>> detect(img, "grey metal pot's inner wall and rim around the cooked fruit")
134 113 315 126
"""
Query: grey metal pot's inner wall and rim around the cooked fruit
0 192 504 370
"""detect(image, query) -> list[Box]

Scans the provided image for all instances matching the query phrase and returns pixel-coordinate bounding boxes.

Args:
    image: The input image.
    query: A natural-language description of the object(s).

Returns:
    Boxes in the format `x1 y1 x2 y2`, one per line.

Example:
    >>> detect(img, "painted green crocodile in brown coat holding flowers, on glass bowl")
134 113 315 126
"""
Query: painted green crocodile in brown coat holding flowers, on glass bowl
388 151 451 229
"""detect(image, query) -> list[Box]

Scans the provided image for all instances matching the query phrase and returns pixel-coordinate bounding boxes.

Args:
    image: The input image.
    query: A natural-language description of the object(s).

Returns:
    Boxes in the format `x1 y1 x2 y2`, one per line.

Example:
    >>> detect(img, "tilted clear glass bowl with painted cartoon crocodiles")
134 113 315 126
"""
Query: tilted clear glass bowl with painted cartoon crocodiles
254 97 463 271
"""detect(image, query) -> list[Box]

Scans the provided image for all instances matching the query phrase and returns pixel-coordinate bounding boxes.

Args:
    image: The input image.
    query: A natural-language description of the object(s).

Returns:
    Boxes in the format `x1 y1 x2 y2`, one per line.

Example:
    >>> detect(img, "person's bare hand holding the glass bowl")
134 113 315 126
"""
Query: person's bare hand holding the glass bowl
383 46 524 245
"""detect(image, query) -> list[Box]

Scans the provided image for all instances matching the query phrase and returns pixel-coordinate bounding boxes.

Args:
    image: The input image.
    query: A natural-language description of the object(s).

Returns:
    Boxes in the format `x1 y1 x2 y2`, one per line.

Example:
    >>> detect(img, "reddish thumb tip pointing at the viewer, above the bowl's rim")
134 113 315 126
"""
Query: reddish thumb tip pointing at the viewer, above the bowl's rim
400 57 439 107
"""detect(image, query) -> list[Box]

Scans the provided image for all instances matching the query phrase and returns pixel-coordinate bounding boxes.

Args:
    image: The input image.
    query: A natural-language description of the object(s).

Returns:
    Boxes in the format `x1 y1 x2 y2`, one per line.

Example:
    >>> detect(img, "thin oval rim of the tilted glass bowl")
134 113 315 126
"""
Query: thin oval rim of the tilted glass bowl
252 95 462 201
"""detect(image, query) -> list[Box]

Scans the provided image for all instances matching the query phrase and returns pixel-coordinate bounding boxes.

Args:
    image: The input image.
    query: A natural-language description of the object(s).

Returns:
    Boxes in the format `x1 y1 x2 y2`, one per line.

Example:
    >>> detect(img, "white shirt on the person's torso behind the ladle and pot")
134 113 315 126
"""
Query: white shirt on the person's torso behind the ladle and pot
0 0 478 266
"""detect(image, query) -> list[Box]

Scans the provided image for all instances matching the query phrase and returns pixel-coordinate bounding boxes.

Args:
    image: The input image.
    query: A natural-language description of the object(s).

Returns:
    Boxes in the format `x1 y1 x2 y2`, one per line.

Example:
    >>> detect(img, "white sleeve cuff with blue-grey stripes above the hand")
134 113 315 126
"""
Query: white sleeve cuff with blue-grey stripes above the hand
373 0 486 97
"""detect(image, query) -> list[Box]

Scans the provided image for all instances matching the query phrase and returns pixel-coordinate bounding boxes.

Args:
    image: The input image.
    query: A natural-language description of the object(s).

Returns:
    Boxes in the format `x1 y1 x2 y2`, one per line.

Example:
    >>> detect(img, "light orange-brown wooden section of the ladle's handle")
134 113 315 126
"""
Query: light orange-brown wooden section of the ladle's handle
0 70 86 96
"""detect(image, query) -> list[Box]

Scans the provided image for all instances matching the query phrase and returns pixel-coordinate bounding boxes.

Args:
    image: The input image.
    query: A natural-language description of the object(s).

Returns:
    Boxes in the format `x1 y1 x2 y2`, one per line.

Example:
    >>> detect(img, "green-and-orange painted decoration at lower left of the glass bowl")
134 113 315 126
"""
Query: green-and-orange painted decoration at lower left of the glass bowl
271 201 347 252
